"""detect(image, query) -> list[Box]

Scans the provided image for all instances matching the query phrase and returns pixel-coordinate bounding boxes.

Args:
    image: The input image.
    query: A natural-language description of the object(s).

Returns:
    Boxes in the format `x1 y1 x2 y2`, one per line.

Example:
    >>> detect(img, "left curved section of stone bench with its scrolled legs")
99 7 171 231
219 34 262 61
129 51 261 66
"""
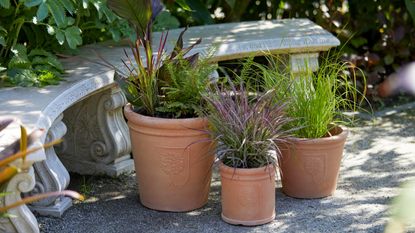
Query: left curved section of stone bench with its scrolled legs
0 58 134 232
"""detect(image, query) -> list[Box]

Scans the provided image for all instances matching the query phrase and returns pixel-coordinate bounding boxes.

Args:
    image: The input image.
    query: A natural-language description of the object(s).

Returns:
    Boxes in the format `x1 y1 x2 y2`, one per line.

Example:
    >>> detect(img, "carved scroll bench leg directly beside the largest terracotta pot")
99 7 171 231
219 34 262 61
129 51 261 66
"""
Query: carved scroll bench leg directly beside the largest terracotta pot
57 85 134 176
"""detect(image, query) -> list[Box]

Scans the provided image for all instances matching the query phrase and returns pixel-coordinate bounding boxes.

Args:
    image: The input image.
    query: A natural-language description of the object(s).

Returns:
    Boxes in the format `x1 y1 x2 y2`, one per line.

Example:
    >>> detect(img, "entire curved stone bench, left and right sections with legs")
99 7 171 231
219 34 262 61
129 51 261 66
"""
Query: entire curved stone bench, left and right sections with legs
0 19 340 232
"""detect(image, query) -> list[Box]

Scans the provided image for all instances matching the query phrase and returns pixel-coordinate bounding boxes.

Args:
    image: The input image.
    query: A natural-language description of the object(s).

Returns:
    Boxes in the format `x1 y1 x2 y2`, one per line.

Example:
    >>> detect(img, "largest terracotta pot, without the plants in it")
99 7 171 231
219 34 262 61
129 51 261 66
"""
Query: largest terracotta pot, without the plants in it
124 105 214 212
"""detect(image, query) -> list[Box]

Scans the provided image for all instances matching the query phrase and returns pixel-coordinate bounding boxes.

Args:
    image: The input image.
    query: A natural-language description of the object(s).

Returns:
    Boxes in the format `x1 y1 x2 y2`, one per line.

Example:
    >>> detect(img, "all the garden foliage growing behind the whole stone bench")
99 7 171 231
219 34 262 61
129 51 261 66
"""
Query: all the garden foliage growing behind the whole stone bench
0 0 415 105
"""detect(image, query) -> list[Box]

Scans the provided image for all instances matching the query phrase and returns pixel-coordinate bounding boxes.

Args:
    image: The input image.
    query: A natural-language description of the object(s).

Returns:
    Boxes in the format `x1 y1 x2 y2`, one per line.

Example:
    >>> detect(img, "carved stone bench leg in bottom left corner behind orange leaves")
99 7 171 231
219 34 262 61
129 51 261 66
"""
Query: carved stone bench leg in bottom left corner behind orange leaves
0 167 39 233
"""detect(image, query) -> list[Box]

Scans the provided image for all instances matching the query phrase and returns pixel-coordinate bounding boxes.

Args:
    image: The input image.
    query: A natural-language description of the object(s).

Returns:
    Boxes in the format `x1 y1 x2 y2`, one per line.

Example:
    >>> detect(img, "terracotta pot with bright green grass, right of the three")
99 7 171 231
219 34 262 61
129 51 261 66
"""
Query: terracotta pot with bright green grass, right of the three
257 53 363 198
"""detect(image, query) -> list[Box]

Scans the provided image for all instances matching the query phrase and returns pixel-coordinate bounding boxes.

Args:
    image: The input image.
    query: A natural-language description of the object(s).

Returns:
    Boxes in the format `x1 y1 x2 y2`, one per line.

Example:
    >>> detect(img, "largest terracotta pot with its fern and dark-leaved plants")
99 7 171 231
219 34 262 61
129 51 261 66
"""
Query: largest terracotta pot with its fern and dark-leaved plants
108 0 216 211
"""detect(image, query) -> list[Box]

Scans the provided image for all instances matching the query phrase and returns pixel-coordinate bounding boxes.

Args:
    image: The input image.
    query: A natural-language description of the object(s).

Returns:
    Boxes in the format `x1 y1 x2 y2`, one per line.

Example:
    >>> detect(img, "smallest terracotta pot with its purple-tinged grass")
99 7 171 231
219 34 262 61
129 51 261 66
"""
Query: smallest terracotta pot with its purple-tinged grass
204 78 289 226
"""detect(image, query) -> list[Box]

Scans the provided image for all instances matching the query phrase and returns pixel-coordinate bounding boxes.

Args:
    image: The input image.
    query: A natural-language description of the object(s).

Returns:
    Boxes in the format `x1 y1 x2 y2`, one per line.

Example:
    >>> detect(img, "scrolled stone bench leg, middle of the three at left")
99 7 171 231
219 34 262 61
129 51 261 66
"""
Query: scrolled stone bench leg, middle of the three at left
29 114 72 217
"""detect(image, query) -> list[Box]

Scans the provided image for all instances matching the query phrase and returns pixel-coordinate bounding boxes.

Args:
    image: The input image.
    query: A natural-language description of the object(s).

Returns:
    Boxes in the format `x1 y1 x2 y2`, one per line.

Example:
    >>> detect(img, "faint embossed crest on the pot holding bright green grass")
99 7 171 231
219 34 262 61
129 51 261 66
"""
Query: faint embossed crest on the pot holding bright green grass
302 154 326 185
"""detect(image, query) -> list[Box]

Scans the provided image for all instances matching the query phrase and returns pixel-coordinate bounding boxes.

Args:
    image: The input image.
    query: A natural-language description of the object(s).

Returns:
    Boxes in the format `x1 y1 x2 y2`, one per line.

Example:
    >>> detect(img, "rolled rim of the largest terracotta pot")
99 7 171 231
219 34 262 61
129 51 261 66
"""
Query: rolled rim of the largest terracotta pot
124 103 208 129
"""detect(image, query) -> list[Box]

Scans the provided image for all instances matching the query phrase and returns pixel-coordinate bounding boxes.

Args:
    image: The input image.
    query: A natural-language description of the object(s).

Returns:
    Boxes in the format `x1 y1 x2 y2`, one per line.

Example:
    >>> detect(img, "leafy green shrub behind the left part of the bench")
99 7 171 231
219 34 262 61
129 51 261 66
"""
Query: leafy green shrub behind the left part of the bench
0 0 131 86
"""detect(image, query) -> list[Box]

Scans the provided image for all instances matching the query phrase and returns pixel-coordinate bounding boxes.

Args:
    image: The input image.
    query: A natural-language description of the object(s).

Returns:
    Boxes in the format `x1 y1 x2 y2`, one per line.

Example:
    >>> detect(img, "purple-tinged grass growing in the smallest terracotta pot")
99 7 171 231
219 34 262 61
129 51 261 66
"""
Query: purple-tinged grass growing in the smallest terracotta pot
204 81 290 168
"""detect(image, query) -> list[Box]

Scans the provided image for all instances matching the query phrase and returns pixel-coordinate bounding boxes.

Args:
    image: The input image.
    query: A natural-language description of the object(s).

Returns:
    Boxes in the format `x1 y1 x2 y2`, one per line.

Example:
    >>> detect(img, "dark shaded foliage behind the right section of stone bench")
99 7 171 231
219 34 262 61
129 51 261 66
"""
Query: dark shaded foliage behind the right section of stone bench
167 0 415 104
